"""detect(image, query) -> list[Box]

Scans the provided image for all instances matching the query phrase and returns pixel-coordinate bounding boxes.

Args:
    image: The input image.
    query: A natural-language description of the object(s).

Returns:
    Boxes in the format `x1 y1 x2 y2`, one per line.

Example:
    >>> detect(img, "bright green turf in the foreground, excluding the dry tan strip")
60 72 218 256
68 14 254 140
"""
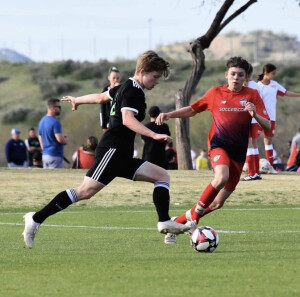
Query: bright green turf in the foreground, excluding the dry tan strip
0 205 300 297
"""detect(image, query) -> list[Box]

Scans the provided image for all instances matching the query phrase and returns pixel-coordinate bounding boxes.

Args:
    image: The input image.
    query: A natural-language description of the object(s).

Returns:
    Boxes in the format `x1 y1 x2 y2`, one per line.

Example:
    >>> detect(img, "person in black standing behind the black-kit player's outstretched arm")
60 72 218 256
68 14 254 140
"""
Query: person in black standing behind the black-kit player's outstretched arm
100 67 121 131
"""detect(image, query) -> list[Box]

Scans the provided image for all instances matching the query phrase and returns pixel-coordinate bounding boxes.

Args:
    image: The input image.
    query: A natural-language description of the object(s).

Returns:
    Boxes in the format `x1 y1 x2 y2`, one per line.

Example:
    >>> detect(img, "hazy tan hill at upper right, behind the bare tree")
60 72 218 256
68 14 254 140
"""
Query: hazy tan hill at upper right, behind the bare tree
156 31 300 62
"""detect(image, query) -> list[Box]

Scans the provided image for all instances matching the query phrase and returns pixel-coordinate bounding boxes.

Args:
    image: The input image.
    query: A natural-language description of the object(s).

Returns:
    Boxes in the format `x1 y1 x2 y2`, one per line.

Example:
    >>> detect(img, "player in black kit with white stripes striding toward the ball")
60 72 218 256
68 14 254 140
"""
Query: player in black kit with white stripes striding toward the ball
23 51 191 248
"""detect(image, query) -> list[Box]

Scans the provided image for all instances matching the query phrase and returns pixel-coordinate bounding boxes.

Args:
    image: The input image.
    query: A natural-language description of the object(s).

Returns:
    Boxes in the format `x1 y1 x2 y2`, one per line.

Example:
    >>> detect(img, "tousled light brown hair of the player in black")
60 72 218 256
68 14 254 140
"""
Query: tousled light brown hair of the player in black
135 51 170 77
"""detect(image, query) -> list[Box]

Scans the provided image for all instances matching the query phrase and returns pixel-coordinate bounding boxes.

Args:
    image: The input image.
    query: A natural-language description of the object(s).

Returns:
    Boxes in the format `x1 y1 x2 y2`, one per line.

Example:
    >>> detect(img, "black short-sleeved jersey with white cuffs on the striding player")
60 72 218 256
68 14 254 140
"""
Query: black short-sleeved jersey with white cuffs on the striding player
98 78 147 158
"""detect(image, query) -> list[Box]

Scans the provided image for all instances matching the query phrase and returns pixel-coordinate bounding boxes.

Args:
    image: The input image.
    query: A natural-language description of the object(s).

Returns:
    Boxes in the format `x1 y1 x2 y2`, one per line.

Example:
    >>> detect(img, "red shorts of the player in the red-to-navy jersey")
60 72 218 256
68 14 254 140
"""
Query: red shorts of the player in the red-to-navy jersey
209 148 244 192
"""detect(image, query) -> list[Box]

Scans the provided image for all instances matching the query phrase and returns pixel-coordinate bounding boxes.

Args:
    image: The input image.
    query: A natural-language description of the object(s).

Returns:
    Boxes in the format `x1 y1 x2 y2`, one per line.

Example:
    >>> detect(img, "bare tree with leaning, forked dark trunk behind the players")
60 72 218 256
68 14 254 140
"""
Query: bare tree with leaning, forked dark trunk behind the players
176 0 257 169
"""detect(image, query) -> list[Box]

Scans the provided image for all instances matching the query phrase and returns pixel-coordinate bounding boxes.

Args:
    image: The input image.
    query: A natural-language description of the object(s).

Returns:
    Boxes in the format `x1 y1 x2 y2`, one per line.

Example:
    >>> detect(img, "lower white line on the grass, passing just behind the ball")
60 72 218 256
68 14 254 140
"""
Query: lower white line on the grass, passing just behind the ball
0 222 300 234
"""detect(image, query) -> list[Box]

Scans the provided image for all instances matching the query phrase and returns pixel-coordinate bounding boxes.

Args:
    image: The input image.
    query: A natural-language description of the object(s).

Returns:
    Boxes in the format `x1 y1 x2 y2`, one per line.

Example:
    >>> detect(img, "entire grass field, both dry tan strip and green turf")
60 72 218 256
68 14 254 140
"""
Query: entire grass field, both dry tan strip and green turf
0 168 300 297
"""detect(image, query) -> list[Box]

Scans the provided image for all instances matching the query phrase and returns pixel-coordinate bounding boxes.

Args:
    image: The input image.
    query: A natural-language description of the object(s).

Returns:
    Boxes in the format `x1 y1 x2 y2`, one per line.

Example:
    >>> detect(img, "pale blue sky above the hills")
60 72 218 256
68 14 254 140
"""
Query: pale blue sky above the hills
0 0 300 62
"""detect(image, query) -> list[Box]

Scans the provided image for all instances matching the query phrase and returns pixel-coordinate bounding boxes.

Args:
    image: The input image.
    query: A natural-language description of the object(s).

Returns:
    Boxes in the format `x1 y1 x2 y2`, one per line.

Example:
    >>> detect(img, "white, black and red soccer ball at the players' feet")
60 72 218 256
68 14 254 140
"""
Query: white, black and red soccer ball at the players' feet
191 226 219 253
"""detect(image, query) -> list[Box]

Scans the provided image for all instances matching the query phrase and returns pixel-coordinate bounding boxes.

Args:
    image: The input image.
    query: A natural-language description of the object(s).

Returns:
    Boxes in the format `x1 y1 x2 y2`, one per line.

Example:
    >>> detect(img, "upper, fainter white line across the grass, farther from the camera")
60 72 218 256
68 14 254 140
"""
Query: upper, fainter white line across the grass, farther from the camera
0 207 300 216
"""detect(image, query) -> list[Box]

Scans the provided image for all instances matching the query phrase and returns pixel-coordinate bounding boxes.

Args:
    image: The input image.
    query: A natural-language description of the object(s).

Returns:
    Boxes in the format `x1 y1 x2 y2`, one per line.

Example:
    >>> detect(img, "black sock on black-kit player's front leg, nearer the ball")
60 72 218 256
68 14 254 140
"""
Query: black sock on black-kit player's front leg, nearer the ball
153 187 170 222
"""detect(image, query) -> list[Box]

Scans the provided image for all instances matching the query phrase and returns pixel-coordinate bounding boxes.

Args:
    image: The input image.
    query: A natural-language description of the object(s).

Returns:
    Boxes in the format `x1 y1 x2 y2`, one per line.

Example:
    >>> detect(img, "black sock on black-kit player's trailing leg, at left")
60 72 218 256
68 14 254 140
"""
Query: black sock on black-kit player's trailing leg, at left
32 191 72 224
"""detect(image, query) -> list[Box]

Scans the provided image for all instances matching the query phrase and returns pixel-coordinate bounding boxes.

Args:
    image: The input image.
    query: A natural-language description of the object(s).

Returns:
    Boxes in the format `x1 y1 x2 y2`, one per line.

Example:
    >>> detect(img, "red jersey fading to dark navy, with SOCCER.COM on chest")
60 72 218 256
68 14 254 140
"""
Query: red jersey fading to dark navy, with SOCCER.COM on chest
191 85 269 162
